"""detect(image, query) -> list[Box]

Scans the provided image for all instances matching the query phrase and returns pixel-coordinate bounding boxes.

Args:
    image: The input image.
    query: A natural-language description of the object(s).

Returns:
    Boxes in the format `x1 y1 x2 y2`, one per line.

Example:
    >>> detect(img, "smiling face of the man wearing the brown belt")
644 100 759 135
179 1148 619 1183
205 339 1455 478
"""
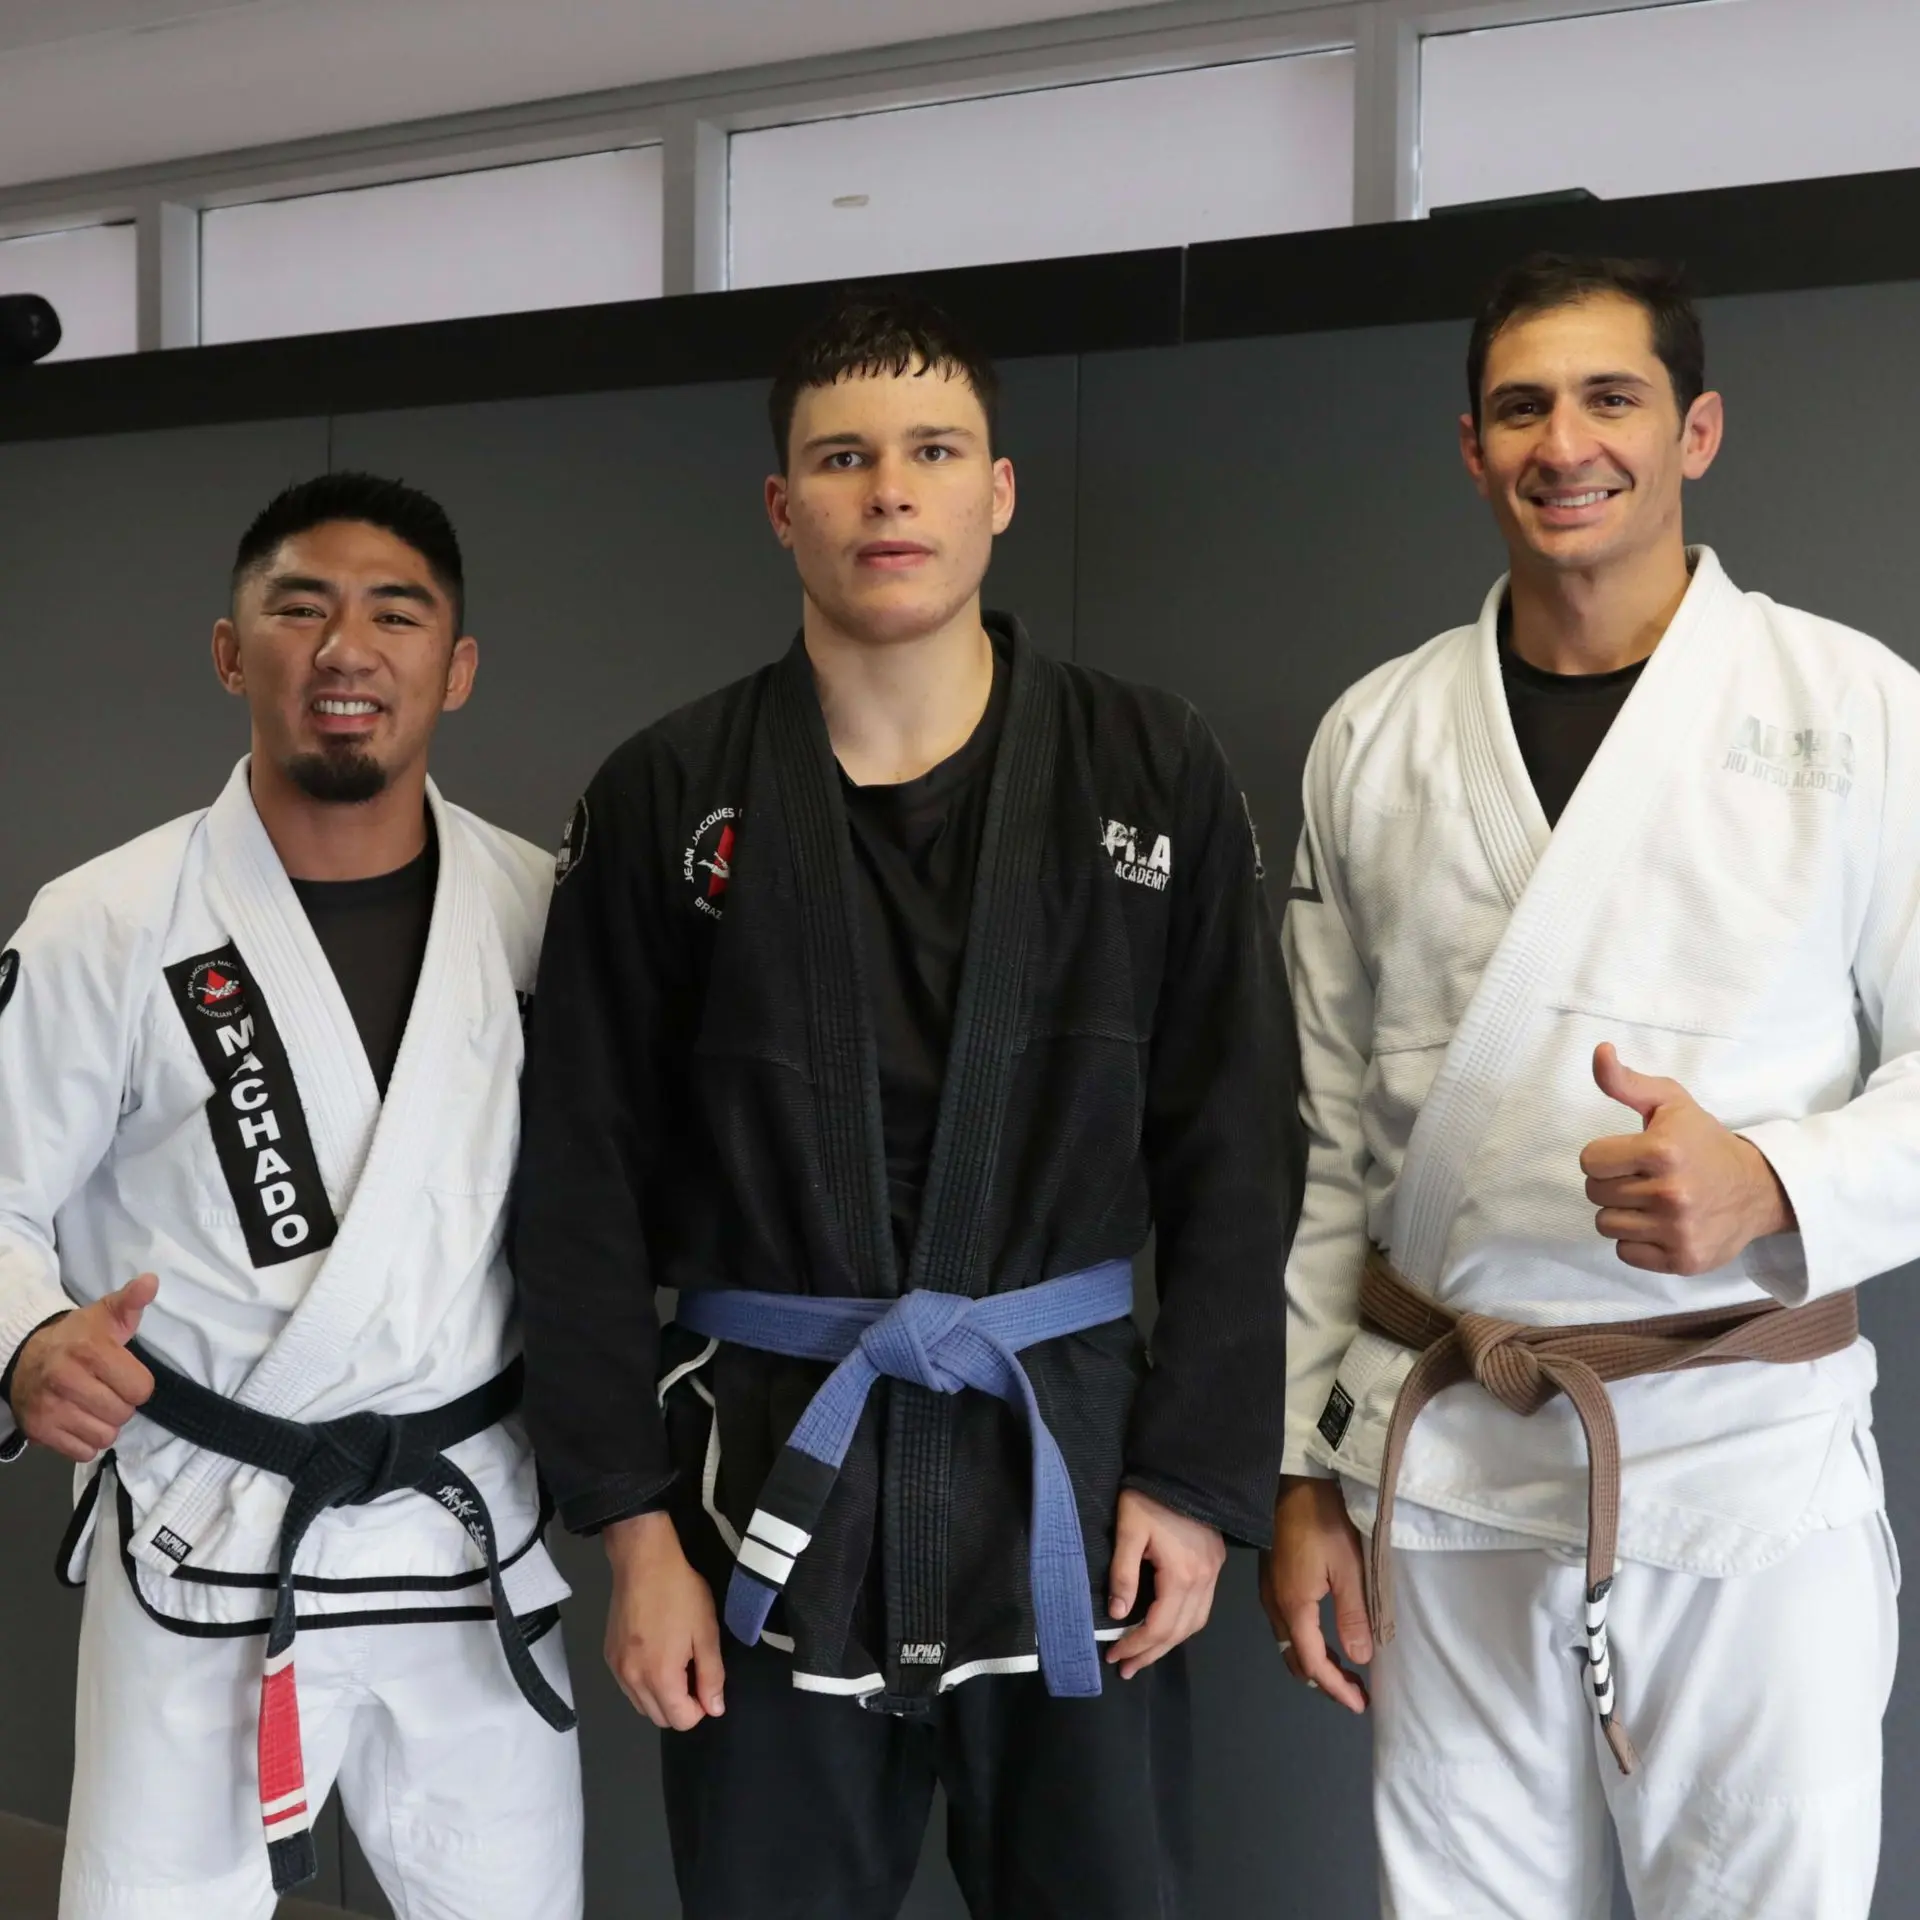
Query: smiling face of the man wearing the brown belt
1461 294 1722 572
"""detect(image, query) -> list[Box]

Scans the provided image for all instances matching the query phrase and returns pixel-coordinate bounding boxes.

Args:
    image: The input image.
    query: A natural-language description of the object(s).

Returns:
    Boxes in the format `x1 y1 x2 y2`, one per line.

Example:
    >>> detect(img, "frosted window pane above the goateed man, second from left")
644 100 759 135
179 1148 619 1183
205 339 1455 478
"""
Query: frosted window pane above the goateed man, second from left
200 146 660 342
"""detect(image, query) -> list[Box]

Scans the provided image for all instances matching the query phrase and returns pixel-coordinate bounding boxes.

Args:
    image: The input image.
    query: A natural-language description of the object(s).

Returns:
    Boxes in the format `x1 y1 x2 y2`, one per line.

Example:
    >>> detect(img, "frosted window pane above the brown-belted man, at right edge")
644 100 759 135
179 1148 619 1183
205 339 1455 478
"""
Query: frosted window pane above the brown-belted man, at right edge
1421 0 1920 207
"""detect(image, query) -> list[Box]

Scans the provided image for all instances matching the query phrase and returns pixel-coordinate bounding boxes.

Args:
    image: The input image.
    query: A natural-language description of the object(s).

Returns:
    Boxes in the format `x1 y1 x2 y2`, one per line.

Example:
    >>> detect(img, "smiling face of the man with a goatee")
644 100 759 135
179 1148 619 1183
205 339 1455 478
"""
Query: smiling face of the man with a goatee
213 520 478 803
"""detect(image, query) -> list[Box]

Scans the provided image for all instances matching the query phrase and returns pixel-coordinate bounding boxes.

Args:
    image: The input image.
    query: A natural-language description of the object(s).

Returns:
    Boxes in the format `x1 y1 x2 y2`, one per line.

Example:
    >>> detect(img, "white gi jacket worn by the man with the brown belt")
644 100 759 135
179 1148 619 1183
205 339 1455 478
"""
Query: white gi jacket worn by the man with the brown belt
1284 549 1920 1574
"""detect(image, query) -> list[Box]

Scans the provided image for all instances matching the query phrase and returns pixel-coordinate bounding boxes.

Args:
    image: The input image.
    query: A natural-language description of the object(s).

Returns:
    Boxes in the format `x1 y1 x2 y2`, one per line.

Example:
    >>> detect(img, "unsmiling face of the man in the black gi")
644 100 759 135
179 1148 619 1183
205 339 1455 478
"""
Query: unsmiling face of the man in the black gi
766 367 1014 645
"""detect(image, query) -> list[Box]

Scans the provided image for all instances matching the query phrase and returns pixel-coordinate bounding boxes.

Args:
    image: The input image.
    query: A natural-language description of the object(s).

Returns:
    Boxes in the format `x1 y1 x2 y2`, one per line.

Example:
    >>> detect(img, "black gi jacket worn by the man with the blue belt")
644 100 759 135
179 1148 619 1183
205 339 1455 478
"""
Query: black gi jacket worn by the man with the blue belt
515 616 1304 1703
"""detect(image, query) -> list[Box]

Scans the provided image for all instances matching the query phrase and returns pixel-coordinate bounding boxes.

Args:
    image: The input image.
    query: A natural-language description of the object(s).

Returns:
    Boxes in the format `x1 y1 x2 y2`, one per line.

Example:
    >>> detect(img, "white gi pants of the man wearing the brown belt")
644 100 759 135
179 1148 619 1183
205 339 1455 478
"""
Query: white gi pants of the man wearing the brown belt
1373 1515 1899 1920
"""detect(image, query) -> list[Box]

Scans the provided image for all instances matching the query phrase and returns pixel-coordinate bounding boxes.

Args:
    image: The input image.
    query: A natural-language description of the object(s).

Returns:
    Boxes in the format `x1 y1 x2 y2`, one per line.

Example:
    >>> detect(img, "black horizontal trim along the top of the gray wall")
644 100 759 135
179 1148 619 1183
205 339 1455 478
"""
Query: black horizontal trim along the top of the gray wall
0 169 1920 440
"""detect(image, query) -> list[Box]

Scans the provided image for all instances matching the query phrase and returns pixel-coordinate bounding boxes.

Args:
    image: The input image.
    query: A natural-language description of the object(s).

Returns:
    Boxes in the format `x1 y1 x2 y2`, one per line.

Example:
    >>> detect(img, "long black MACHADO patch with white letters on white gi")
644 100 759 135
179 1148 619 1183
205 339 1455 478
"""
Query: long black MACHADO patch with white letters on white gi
167 947 340 1267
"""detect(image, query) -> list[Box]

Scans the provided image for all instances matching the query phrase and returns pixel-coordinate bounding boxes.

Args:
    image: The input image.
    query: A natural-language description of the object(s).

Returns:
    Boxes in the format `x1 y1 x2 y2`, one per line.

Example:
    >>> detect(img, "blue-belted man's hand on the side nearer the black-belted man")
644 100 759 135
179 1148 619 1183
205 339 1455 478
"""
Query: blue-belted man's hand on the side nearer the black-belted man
603 1513 726 1734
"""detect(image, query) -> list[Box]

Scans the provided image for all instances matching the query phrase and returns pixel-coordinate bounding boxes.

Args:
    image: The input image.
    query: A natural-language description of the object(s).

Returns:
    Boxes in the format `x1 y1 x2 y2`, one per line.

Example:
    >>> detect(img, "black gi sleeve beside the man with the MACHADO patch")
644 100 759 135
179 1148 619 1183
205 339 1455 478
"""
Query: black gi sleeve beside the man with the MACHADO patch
513 762 674 1532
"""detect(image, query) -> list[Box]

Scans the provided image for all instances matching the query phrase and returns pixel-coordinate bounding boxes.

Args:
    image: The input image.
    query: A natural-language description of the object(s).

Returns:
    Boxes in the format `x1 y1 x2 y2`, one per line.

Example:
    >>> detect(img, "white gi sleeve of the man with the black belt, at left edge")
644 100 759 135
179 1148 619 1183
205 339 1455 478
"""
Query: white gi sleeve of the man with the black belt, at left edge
0 883 138 1459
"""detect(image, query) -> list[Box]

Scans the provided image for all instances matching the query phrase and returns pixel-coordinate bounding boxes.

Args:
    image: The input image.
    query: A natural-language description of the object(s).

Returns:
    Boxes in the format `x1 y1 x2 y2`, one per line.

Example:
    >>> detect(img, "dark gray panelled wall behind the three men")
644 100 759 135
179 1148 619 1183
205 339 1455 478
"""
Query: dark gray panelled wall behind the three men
0 286 1920 1920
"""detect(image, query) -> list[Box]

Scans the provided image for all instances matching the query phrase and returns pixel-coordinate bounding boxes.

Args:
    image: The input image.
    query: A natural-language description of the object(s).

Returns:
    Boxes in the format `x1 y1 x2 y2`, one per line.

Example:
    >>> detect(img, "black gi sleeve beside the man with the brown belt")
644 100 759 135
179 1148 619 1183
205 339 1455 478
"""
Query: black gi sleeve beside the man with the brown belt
1123 712 1304 1546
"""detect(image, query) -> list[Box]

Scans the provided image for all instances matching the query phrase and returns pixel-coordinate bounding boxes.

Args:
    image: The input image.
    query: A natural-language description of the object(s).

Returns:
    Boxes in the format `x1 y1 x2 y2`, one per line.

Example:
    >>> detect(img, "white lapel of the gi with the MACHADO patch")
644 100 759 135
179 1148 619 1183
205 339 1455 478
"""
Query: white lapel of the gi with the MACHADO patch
132 760 495 1572
